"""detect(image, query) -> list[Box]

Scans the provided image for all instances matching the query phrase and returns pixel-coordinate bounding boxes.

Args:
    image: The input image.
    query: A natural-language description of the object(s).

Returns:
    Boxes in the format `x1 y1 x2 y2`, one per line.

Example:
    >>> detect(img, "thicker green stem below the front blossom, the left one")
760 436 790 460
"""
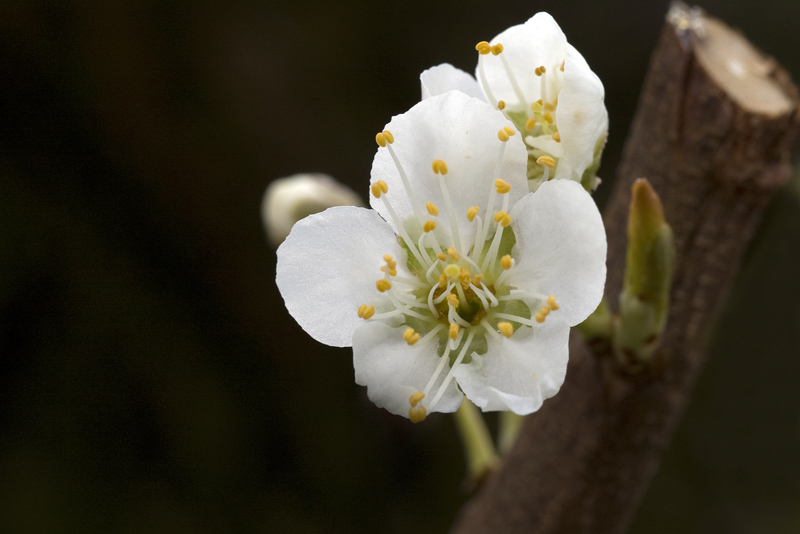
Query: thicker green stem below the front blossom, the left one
455 397 499 485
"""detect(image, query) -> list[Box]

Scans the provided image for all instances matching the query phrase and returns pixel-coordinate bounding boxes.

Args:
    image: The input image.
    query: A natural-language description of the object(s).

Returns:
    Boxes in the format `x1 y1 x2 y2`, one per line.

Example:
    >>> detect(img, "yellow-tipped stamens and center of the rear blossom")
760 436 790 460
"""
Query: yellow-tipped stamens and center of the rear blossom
475 41 564 182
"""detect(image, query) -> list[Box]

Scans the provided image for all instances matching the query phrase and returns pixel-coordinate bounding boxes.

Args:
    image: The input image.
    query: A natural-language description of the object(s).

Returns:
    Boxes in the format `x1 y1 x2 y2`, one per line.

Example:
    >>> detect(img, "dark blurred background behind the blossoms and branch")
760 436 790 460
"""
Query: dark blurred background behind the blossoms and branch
0 0 800 534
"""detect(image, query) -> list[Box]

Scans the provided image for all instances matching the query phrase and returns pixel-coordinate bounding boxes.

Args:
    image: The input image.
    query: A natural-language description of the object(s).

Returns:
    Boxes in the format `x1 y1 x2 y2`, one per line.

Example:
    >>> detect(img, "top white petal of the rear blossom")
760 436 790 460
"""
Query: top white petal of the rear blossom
476 12 567 111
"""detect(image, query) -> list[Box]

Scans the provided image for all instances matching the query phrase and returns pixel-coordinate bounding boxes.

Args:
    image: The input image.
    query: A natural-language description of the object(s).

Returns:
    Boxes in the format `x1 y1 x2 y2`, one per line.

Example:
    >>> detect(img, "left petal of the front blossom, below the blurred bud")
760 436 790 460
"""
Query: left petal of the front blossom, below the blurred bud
276 206 407 347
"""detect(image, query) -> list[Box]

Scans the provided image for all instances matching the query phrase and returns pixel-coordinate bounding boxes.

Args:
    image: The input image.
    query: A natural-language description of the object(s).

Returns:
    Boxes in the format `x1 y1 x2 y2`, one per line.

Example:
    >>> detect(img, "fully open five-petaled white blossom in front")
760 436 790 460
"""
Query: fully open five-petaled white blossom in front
277 91 606 422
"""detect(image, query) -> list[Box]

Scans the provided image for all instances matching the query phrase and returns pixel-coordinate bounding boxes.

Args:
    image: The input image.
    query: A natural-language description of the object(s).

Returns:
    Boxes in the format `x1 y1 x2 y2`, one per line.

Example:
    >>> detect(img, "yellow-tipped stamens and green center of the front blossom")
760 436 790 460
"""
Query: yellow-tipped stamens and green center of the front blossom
364 126 558 422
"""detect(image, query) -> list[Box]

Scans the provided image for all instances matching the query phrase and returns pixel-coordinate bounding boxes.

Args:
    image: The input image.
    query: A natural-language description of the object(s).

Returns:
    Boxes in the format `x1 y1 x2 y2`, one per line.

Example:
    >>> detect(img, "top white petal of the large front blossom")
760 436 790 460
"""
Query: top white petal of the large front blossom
370 91 528 247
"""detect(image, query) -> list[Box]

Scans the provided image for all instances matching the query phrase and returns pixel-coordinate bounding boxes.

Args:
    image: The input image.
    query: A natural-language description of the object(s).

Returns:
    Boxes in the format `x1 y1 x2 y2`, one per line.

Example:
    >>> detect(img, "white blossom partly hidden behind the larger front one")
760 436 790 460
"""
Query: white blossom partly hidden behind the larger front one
420 13 608 190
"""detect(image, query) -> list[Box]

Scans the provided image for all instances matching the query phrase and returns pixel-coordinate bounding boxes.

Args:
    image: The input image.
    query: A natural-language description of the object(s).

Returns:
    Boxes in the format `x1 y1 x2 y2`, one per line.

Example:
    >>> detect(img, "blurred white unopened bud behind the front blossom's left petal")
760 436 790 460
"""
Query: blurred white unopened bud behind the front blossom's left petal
261 173 364 247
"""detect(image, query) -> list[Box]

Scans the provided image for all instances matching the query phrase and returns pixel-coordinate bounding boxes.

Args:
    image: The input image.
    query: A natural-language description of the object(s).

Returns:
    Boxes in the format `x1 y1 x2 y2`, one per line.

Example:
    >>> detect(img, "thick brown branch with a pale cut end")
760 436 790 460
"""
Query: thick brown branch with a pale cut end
453 7 798 534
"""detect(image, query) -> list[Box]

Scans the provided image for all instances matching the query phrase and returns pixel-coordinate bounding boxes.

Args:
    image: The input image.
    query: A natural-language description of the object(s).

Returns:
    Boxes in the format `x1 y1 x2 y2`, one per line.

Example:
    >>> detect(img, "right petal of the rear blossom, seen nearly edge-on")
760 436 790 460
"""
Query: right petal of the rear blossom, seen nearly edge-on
556 45 608 181
